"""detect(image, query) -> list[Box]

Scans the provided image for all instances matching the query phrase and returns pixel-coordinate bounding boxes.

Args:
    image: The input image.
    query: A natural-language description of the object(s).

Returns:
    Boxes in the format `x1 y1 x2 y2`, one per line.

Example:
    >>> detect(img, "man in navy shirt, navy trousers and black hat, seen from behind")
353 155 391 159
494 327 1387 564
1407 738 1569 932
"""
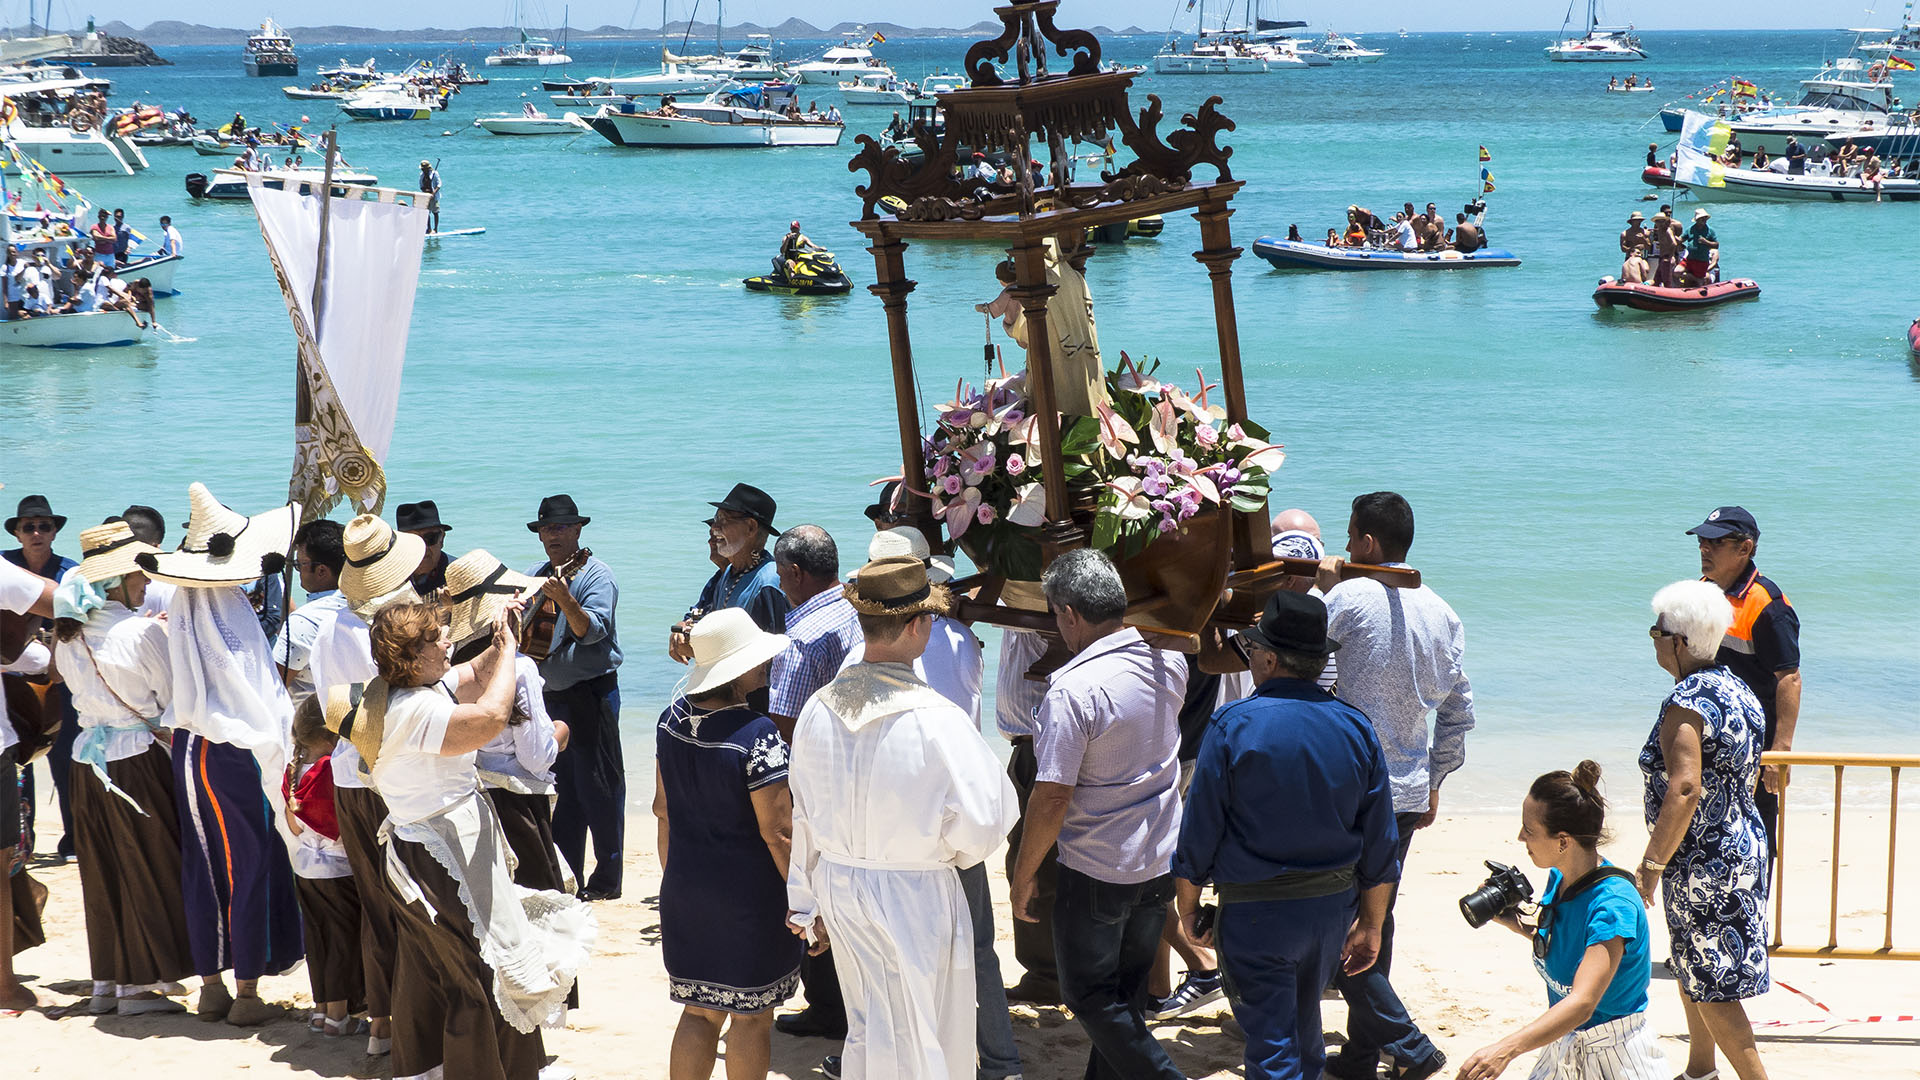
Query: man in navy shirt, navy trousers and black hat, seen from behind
1173 592 1397 1080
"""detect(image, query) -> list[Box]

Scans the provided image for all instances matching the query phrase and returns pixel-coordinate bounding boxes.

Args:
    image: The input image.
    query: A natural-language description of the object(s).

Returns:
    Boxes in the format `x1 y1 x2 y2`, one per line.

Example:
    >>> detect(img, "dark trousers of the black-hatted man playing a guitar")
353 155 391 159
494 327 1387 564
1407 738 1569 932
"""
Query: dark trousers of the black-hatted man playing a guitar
545 671 626 894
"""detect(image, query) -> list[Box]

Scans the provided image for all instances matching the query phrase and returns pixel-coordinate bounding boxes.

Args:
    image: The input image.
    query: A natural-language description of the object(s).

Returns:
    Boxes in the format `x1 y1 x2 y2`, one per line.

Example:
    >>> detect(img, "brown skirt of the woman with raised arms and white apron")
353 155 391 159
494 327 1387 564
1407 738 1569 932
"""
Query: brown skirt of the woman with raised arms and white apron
390 838 547 1080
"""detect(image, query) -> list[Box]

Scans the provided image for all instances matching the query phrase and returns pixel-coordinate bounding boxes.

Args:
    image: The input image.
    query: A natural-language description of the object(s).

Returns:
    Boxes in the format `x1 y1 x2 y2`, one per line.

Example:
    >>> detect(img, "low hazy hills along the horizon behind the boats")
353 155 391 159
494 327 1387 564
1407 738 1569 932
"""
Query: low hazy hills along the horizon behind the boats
86 19 1146 46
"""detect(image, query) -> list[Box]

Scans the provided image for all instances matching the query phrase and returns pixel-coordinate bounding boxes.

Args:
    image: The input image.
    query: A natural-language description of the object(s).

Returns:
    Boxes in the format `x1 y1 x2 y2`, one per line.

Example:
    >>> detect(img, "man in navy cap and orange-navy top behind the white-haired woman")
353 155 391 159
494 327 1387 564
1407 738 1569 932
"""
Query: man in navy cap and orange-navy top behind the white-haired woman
1688 505 1801 851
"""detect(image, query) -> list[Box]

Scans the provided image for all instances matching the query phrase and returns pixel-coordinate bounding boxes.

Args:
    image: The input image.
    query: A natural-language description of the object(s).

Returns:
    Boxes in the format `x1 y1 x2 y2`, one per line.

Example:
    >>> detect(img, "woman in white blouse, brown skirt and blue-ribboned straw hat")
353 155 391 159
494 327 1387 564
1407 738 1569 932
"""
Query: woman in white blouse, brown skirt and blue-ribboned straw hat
49 521 194 1017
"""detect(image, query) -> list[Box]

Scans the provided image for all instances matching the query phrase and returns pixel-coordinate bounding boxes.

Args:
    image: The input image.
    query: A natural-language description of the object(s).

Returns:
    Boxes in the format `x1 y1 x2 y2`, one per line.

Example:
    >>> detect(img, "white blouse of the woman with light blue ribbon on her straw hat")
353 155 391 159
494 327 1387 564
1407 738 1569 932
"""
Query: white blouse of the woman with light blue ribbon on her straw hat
54 595 173 761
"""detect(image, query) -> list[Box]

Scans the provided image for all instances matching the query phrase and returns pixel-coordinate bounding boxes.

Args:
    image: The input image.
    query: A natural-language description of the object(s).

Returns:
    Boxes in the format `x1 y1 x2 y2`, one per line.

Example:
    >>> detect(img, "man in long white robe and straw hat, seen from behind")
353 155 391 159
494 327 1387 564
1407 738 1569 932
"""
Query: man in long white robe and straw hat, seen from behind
787 555 1018 1080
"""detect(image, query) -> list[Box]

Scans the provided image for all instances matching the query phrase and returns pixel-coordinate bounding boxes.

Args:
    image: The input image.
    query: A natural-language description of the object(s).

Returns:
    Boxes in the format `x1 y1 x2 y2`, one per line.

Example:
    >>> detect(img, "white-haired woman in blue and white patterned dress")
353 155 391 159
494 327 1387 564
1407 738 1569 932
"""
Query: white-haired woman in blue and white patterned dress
1636 580 1770 1080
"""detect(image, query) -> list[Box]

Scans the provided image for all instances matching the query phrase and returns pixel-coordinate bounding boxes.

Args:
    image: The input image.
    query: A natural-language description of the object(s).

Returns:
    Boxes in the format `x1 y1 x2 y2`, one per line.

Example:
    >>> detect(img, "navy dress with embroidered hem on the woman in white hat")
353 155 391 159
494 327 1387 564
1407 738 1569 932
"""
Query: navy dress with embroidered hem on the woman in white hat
655 698 803 1013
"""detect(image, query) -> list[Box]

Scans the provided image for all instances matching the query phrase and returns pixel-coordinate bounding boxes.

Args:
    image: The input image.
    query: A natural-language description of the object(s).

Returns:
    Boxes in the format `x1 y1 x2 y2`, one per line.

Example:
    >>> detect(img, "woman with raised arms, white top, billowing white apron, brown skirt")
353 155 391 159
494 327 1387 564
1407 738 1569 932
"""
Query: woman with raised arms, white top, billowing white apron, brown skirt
362 603 593 1080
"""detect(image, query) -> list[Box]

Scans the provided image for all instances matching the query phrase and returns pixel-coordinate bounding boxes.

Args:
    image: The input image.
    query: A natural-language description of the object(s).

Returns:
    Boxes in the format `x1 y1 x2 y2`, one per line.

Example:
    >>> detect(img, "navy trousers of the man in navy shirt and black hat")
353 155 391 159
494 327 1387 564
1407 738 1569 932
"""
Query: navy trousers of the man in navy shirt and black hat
1213 890 1359 1080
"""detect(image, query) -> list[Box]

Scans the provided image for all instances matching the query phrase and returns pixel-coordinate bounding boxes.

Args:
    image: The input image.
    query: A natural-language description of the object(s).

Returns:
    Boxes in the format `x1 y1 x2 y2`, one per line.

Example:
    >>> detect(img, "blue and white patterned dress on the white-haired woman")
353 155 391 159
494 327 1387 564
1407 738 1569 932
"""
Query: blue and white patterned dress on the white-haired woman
1640 667 1770 1001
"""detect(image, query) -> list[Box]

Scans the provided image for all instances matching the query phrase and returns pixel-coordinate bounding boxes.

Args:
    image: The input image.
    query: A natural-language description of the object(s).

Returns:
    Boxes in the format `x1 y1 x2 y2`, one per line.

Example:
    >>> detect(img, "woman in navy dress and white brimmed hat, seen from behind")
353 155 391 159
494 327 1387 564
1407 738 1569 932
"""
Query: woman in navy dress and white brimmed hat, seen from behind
653 607 801 1080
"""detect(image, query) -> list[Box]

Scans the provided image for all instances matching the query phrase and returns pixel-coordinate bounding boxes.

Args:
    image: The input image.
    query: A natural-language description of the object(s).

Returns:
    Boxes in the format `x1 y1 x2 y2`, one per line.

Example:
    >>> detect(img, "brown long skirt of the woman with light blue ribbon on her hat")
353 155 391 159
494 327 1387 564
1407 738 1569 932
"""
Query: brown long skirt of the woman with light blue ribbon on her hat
71 744 194 986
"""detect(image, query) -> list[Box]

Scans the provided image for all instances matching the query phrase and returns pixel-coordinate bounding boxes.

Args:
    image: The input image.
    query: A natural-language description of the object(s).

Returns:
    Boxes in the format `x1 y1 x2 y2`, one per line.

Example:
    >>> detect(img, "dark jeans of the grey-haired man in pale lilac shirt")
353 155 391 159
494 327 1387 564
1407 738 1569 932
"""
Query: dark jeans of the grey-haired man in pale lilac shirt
1054 867 1181 1080
